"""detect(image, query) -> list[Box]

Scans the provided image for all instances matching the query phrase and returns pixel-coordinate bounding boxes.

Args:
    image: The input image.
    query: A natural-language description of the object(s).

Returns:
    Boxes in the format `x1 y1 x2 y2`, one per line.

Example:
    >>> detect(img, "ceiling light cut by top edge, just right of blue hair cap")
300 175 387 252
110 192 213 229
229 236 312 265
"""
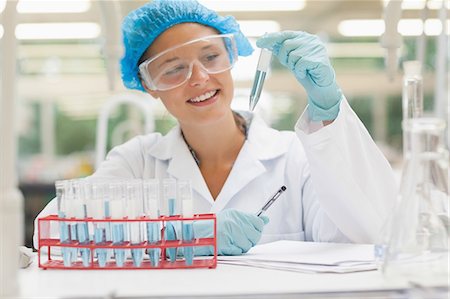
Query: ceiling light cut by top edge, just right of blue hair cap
199 0 305 11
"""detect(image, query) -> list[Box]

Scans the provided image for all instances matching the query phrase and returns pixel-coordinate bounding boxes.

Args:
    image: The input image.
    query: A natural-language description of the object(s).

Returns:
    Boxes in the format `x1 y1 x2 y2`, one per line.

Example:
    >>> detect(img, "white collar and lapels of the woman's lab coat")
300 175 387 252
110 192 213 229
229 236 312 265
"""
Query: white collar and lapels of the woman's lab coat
148 111 288 212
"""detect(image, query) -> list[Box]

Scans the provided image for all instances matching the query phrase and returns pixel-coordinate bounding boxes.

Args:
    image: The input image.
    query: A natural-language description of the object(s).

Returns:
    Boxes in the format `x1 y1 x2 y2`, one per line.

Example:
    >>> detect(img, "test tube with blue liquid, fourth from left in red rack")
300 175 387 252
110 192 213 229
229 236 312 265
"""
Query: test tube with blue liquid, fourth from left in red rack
109 183 126 267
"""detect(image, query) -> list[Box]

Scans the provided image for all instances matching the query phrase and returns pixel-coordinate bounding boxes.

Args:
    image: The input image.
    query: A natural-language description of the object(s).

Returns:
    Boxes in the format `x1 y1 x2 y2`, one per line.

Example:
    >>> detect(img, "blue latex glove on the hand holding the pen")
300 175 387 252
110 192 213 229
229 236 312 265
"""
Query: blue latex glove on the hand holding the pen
194 209 269 255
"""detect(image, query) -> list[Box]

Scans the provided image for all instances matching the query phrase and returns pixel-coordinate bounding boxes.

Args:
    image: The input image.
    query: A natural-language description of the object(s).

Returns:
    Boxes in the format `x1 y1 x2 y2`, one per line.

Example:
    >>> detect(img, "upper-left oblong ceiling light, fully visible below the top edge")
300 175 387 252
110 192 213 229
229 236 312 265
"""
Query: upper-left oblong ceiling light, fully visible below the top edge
16 23 101 40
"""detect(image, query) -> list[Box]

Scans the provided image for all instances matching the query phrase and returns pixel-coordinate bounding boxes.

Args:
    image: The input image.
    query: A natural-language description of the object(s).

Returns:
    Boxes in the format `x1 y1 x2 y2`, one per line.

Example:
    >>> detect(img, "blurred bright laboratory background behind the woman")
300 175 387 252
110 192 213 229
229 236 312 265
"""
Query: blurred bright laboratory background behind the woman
0 0 450 246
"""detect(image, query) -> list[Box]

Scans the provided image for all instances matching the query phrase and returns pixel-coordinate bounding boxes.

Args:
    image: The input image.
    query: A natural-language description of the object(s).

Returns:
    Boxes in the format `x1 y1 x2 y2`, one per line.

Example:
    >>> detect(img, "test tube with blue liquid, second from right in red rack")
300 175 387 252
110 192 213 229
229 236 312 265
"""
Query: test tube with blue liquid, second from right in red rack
163 179 178 263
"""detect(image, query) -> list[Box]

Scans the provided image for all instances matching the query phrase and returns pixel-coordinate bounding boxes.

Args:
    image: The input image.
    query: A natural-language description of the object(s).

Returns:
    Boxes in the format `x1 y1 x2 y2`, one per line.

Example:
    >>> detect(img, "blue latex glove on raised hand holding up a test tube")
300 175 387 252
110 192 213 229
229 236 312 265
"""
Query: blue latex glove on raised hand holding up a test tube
256 31 342 121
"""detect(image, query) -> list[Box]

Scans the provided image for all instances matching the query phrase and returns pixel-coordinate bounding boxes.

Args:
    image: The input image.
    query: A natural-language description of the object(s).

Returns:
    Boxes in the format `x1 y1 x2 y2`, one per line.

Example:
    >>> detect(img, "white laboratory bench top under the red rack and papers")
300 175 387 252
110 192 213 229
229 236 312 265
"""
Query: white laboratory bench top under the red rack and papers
18 257 449 299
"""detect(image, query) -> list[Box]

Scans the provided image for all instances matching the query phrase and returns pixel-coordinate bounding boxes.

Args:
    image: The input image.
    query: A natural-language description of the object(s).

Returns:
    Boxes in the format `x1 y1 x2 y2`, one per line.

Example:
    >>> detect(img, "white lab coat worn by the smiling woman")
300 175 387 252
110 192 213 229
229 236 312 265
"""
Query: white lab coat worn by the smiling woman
34 99 397 248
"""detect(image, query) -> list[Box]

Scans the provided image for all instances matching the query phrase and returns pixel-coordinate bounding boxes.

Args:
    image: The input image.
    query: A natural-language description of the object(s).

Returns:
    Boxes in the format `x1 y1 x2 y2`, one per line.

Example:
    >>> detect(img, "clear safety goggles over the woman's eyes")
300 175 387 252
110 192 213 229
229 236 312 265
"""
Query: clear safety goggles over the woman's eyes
139 34 238 91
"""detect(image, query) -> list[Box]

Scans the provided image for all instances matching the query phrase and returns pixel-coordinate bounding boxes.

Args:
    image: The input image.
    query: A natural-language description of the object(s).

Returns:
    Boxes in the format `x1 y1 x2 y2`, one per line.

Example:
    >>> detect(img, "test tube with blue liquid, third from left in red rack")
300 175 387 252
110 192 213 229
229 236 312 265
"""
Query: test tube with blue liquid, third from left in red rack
88 182 108 267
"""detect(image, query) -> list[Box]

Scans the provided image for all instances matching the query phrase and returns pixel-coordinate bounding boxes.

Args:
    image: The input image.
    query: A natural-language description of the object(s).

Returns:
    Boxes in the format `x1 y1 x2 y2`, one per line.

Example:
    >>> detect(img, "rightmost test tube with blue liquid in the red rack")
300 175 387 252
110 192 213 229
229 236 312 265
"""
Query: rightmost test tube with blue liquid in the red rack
178 181 194 266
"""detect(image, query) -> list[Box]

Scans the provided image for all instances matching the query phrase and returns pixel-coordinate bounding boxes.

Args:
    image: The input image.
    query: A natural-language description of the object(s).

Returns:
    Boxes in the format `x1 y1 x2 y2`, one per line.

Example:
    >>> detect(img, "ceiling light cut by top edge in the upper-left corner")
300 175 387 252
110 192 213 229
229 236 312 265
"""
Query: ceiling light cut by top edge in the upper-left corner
17 0 91 13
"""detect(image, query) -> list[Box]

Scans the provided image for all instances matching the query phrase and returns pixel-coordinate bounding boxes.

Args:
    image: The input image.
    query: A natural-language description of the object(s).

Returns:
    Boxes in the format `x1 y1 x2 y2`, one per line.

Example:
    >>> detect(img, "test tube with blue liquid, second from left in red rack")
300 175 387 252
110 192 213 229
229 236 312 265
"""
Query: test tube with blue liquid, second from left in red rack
72 180 90 267
